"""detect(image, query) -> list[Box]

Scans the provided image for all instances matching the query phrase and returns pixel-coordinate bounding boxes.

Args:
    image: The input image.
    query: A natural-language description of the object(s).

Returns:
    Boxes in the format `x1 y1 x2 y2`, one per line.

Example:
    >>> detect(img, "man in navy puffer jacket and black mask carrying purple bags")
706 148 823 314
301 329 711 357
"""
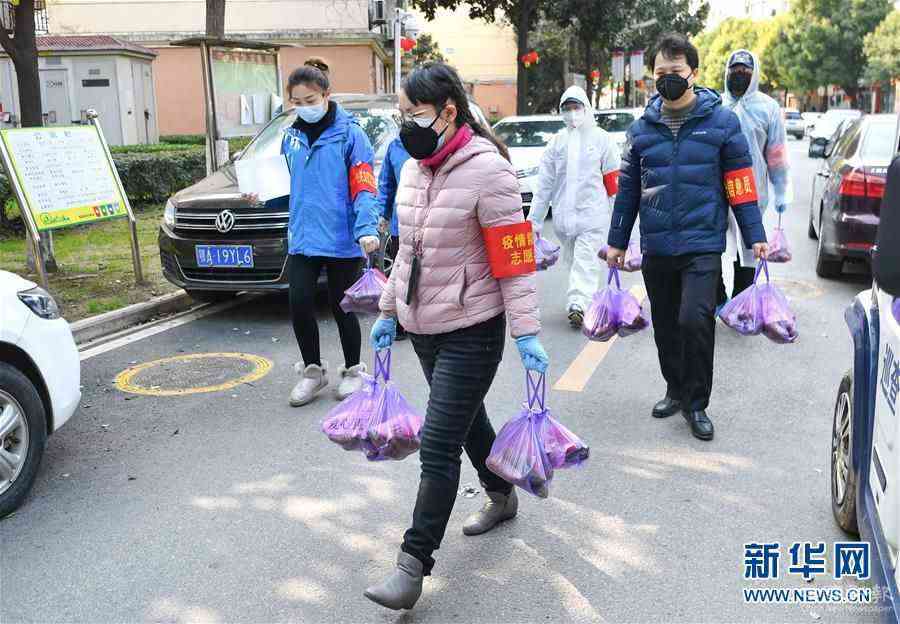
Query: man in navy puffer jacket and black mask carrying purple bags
607 34 768 440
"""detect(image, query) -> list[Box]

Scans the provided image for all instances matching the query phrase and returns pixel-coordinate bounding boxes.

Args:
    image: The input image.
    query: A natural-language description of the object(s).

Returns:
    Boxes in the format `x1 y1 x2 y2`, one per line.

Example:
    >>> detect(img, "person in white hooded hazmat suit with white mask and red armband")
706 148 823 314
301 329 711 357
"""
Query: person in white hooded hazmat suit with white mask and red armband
528 86 619 328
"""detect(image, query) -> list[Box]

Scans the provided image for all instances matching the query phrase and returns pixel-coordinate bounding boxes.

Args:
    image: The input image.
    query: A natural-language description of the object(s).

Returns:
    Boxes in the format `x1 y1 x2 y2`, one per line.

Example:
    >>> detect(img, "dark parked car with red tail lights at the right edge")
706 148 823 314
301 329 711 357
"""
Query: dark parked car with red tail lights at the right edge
809 115 897 278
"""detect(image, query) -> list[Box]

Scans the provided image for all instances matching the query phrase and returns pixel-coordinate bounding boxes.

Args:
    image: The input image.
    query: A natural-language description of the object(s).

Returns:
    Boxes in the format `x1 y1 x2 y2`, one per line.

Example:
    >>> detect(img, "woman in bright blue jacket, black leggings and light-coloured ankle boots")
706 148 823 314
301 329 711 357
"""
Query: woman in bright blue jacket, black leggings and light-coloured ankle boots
281 59 379 407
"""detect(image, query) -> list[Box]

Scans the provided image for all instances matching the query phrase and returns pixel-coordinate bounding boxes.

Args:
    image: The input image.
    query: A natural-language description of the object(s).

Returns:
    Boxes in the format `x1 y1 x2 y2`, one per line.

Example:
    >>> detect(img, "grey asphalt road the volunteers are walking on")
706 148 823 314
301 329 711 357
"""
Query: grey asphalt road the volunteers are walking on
0 140 875 623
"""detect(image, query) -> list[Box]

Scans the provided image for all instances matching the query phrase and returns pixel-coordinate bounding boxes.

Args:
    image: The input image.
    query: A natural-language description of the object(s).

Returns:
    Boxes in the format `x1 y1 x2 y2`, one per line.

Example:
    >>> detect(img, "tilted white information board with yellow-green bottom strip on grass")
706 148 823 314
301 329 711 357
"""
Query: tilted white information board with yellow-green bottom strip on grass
0 125 128 231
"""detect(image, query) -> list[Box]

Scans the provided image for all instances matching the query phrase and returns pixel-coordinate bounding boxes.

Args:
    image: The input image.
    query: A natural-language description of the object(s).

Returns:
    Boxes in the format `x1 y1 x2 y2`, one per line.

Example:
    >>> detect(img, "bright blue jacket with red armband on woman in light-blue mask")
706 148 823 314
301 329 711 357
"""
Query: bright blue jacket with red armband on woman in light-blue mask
281 106 378 258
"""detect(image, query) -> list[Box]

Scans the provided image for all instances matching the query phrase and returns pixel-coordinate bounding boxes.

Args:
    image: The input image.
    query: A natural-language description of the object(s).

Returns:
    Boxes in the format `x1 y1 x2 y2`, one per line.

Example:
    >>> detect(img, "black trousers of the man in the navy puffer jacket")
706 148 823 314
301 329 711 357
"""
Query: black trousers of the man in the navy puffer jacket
641 254 722 411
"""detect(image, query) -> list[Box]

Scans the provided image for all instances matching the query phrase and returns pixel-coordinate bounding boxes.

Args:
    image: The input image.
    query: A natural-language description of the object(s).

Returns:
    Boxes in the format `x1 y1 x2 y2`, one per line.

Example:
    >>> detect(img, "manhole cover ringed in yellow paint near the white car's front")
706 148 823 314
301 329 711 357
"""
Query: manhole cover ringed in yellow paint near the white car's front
115 353 272 396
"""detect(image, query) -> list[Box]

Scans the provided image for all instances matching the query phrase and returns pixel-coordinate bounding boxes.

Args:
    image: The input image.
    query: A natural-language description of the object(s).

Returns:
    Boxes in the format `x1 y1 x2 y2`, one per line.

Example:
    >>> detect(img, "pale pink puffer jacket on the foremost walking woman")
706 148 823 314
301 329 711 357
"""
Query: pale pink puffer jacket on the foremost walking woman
381 136 541 338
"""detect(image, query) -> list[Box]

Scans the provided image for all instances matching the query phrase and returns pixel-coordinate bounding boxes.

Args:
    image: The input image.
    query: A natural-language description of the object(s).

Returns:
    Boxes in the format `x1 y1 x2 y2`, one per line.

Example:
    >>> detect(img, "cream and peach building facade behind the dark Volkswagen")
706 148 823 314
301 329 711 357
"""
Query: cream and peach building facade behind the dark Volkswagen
48 0 393 135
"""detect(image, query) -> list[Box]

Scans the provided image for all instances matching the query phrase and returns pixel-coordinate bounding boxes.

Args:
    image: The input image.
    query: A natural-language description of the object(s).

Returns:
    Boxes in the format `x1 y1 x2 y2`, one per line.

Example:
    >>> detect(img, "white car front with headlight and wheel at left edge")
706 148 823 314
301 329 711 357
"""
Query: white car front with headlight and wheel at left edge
0 271 81 518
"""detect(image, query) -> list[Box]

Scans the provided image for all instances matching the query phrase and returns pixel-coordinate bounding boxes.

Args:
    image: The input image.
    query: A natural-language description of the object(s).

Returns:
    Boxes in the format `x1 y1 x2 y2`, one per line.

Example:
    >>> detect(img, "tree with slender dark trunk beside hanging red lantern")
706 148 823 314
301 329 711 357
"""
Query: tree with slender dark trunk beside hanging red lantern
412 0 550 115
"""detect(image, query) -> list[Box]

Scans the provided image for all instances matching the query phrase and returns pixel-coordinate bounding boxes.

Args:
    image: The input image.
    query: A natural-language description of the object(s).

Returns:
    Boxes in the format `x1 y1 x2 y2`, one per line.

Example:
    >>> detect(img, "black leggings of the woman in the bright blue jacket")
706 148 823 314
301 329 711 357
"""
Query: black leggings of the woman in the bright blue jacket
288 255 362 368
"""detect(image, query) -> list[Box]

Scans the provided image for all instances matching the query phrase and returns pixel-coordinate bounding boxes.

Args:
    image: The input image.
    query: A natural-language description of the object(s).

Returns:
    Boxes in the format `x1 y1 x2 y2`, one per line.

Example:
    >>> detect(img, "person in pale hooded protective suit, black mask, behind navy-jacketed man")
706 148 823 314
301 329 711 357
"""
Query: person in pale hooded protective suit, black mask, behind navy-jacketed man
718 50 793 306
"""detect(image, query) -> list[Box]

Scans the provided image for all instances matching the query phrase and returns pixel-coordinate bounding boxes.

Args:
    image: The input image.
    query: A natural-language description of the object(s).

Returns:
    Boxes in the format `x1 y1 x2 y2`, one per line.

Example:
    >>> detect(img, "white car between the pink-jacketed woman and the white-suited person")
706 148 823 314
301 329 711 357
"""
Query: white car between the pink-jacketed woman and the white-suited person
494 115 565 214
